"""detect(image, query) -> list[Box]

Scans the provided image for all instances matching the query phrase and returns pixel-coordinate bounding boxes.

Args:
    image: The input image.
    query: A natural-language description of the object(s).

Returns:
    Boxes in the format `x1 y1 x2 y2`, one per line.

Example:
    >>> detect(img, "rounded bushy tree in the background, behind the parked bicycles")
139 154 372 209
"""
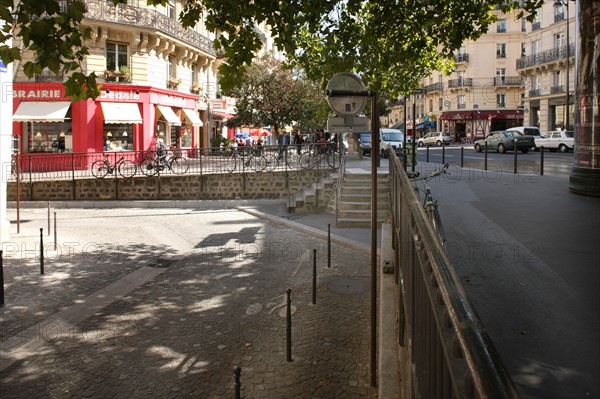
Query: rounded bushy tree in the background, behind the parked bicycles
224 56 327 136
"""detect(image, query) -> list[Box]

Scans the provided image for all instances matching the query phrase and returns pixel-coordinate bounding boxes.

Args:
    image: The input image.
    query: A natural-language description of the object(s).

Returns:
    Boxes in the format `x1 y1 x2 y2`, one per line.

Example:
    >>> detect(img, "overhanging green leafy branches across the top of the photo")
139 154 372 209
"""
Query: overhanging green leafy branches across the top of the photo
0 0 544 98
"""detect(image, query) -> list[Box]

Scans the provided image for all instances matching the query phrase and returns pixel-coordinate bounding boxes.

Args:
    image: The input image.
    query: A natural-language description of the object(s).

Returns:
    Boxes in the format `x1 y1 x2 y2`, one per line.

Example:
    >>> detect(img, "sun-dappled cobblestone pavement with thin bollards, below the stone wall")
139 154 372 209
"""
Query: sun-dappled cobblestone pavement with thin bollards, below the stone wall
0 208 376 399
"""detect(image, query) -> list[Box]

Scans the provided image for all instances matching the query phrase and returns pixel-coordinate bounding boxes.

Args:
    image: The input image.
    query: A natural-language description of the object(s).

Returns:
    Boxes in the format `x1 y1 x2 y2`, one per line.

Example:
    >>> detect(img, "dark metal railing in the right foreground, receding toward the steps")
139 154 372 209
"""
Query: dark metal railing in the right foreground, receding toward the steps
390 154 519 399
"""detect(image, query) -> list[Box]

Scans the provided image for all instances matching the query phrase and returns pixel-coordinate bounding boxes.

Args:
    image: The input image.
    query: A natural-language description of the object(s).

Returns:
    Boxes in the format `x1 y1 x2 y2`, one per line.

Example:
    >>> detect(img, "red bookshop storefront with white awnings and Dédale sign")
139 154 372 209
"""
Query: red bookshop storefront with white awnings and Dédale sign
13 83 203 165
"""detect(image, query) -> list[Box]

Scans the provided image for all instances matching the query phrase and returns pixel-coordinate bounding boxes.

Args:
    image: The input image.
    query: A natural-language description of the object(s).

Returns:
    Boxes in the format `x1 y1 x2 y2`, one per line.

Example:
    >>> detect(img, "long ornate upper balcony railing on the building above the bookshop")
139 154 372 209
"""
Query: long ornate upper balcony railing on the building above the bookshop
85 0 216 55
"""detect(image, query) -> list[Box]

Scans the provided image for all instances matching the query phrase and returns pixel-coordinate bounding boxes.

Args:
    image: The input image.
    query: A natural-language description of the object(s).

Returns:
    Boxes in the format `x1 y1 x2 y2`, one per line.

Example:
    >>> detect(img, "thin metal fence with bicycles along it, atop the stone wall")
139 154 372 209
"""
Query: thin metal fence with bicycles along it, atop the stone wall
5 144 342 183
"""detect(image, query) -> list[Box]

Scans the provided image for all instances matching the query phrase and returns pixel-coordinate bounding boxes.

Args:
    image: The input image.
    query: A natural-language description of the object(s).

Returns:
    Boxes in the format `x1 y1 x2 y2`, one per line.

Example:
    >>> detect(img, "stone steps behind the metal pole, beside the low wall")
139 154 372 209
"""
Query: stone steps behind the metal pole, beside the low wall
337 173 390 227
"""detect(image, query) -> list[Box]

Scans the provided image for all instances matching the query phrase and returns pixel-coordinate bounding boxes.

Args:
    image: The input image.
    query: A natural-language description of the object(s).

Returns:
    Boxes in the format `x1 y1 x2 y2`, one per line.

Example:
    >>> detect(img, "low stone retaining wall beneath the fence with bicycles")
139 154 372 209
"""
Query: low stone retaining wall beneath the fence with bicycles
8 170 331 201
